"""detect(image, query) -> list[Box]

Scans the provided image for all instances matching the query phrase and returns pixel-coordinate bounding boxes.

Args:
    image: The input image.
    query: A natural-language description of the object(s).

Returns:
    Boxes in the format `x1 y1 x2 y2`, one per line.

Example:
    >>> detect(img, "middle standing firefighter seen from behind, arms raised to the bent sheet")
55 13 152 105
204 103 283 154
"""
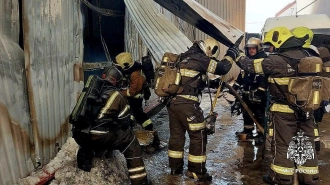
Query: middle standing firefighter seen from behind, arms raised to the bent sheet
167 38 234 181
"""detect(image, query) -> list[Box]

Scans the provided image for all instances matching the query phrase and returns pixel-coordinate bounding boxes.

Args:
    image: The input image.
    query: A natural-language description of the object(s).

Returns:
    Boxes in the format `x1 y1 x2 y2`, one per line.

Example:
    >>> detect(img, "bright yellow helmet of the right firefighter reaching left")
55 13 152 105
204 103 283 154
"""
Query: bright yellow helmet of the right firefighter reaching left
263 27 293 48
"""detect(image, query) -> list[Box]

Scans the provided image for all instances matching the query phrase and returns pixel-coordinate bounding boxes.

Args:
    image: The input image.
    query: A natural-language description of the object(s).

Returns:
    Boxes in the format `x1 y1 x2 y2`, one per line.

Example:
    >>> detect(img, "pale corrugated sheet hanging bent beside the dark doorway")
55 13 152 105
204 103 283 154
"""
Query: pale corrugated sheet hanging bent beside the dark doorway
125 0 192 61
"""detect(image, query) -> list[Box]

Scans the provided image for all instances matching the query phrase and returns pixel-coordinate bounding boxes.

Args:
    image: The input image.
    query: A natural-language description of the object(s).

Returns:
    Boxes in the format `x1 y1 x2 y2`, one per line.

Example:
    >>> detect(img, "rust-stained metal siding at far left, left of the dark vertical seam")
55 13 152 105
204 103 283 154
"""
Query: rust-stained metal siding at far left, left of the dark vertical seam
0 0 34 185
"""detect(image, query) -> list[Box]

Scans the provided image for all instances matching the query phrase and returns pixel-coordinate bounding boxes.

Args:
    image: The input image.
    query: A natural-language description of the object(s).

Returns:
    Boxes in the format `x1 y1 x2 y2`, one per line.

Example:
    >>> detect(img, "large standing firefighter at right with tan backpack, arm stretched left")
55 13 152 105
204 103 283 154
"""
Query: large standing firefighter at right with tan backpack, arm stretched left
229 27 329 185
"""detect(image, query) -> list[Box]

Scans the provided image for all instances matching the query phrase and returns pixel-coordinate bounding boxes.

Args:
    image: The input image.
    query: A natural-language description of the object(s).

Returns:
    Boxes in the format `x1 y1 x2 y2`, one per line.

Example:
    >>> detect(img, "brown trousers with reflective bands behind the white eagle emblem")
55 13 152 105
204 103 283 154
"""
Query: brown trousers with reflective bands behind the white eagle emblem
270 112 319 185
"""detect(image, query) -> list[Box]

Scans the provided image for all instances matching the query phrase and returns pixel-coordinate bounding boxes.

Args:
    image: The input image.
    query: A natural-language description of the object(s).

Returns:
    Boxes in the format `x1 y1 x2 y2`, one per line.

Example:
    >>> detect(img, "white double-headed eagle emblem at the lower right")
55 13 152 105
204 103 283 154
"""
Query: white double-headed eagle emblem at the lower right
287 132 314 166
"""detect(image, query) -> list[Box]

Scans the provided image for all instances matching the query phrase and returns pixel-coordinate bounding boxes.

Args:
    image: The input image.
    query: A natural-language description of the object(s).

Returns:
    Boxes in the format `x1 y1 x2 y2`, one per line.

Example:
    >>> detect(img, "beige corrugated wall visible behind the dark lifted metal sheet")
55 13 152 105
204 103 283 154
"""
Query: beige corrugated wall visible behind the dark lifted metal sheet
155 0 246 79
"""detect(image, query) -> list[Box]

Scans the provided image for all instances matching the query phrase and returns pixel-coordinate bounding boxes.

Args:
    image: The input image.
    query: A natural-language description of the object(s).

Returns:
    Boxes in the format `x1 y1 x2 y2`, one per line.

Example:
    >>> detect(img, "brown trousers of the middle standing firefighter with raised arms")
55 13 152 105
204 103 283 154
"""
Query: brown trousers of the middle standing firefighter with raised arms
167 100 207 175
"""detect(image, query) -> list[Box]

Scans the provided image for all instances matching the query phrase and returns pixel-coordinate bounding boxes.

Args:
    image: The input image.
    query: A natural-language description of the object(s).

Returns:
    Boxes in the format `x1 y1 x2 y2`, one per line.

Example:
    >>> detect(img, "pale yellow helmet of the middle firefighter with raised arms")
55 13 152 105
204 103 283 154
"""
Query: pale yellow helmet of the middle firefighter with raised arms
197 38 220 58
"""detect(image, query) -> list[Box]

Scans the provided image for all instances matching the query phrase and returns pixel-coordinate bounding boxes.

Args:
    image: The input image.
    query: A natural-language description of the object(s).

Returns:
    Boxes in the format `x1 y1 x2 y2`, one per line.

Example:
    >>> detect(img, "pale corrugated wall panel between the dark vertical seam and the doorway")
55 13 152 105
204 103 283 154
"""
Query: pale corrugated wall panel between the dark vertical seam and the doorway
23 0 83 169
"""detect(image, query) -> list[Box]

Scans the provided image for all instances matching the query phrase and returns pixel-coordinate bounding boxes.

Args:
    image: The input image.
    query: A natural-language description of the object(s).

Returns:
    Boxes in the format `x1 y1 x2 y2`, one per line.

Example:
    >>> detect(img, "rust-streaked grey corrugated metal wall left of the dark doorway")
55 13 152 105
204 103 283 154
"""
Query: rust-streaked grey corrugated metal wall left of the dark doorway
0 0 83 185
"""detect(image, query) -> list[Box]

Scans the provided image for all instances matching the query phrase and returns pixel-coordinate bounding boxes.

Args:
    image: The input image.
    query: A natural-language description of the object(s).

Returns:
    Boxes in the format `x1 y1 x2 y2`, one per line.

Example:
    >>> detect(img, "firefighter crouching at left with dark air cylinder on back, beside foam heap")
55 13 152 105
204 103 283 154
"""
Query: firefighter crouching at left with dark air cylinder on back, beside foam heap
70 67 148 185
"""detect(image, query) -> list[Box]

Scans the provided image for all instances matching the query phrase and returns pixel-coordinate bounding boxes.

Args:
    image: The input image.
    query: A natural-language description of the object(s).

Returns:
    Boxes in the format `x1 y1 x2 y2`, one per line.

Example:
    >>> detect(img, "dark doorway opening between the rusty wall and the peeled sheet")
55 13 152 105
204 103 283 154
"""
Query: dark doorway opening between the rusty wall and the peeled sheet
81 0 125 80
